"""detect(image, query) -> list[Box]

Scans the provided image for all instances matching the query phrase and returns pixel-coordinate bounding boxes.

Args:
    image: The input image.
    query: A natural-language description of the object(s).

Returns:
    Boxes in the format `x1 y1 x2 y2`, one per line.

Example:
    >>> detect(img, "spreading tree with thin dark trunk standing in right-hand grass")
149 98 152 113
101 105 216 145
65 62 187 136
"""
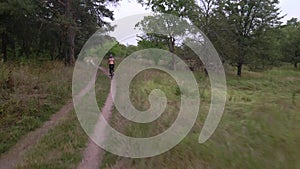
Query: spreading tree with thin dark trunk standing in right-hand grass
217 0 281 76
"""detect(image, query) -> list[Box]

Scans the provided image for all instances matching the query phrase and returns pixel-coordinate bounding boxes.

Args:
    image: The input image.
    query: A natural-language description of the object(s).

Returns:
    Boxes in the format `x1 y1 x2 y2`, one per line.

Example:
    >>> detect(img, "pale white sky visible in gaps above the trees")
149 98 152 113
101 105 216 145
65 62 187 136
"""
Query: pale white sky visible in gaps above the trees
106 0 300 45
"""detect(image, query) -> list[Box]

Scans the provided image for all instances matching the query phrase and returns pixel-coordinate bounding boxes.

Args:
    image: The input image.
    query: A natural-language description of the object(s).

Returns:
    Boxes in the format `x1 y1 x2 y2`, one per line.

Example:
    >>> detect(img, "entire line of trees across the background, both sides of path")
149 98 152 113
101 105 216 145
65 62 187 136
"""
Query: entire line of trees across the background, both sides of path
0 0 300 76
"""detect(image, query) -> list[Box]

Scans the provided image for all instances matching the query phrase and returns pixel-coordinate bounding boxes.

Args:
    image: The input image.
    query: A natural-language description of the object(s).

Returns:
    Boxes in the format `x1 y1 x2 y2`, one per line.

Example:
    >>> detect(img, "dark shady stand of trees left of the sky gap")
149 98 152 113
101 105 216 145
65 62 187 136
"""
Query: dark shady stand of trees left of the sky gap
0 0 118 66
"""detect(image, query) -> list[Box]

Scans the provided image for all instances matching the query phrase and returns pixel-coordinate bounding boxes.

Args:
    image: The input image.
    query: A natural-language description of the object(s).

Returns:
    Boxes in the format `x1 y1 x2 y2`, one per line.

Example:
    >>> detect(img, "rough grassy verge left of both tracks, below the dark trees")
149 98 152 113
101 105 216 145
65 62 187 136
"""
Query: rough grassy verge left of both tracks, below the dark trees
0 62 72 154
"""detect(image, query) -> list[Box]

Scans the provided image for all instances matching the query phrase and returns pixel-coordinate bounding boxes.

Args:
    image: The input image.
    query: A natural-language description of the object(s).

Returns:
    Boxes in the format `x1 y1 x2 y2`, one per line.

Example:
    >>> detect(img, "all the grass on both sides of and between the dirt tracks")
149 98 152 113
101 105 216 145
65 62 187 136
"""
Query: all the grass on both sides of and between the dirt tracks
0 61 300 169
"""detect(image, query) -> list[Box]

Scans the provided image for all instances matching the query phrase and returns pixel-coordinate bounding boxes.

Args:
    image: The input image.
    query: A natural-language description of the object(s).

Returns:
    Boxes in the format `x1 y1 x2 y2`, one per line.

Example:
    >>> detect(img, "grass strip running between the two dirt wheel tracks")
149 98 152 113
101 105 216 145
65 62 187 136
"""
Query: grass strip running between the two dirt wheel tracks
17 69 110 169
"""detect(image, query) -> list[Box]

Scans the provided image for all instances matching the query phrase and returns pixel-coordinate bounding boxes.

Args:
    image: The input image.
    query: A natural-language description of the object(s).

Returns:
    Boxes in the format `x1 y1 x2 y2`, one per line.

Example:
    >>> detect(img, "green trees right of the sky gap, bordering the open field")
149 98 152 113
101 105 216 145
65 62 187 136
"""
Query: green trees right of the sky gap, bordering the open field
134 0 300 76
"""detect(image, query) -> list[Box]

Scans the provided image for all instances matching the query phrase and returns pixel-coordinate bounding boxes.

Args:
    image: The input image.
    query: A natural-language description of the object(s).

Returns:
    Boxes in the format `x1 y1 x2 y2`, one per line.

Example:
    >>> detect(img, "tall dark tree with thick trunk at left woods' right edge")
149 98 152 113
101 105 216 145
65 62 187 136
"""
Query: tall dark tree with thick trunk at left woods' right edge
45 0 118 66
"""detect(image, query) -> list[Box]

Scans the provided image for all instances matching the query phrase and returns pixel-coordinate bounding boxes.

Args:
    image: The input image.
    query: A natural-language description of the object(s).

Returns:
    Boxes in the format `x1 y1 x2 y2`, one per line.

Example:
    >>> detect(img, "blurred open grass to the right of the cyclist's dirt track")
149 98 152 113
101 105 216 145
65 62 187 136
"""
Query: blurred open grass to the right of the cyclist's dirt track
102 68 300 169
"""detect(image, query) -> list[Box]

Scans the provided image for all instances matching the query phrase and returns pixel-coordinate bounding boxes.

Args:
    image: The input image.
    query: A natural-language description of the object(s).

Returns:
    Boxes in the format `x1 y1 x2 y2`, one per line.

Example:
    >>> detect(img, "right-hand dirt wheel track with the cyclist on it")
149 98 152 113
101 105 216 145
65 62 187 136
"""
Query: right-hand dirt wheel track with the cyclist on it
78 68 114 169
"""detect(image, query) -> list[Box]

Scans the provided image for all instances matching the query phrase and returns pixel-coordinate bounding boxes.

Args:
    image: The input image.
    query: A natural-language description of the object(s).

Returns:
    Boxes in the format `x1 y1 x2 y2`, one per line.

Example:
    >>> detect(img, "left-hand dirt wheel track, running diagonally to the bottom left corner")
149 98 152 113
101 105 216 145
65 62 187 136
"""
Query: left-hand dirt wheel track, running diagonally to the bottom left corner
0 70 98 169
